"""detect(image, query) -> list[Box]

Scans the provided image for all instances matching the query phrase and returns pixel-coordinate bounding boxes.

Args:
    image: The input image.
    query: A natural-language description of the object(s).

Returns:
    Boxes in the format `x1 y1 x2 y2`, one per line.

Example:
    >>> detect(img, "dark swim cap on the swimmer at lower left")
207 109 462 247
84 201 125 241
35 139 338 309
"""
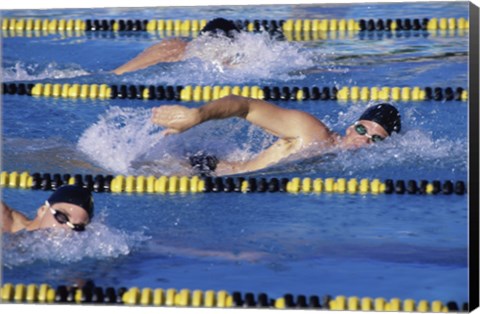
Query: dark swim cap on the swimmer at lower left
48 185 93 219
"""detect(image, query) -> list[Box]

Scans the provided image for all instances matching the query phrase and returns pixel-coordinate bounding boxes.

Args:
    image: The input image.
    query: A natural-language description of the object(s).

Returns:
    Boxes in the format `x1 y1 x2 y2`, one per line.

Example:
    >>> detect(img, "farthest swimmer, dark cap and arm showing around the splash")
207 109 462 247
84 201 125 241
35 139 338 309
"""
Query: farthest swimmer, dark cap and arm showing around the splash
113 18 240 75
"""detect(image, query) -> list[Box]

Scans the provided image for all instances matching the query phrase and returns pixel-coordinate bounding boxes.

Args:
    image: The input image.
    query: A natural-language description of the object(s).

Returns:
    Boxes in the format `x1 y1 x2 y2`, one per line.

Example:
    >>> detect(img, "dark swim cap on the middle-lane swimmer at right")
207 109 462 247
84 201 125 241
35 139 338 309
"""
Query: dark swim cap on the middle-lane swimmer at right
358 103 402 135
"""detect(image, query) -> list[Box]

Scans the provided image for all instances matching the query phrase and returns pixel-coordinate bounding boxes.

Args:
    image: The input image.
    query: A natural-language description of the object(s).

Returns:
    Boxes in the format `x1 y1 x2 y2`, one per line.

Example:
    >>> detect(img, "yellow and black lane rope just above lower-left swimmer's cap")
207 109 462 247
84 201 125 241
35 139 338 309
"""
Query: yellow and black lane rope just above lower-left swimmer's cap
0 171 467 195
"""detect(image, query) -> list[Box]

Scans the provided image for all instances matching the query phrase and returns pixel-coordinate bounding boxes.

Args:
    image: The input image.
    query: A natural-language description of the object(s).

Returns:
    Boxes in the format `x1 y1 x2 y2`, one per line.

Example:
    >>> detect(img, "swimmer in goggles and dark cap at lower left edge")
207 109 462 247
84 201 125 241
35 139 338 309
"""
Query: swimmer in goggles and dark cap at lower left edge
0 185 93 233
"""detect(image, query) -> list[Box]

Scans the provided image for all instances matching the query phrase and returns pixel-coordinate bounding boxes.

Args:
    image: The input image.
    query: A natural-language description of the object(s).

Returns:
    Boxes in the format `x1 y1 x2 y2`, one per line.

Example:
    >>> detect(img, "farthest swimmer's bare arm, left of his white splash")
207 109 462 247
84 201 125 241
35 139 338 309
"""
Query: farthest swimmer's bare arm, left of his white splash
113 38 188 75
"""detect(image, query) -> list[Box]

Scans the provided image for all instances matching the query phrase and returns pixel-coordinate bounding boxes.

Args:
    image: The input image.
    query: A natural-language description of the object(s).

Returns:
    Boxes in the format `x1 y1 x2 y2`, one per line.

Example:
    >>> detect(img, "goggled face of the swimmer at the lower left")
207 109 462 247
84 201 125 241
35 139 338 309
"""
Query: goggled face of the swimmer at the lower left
38 202 90 231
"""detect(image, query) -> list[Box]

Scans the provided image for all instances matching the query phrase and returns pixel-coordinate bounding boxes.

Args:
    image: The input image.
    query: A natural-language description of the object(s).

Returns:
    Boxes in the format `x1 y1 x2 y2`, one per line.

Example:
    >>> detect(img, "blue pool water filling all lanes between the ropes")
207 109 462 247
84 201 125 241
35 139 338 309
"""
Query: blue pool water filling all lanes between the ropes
2 2 468 302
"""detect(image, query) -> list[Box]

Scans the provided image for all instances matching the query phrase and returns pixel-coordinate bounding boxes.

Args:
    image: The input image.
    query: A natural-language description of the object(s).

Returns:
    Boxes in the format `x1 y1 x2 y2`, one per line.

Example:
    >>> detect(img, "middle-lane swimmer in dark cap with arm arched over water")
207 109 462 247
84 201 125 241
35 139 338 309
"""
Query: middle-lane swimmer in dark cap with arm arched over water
151 95 401 175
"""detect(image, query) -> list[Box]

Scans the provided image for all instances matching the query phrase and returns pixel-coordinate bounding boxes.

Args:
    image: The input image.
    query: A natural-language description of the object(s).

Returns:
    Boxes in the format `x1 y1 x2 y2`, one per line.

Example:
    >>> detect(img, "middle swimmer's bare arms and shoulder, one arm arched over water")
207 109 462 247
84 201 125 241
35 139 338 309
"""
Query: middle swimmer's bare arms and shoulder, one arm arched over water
152 95 336 175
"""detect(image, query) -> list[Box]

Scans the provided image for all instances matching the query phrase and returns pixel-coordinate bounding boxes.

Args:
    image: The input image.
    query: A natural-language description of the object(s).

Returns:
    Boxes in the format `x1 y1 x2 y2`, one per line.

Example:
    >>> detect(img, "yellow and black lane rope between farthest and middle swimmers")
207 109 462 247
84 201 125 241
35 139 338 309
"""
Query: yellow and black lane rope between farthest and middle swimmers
2 83 468 102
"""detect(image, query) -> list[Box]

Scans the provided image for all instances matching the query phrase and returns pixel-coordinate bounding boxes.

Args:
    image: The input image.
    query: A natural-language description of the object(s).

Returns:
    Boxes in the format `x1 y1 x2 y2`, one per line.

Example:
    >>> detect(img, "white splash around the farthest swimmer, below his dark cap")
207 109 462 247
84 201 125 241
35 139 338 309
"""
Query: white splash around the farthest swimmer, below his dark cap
130 33 319 85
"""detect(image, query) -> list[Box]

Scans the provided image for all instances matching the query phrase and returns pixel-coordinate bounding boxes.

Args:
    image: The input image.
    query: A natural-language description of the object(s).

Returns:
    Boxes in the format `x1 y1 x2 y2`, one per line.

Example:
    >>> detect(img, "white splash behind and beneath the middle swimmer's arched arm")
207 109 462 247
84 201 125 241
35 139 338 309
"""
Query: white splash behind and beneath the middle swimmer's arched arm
77 107 272 175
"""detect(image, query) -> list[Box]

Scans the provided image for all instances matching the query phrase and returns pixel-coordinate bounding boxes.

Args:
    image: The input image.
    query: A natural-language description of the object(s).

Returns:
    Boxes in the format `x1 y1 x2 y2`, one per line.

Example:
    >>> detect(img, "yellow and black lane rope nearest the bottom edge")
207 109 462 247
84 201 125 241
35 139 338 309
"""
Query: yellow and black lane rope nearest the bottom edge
0 282 468 313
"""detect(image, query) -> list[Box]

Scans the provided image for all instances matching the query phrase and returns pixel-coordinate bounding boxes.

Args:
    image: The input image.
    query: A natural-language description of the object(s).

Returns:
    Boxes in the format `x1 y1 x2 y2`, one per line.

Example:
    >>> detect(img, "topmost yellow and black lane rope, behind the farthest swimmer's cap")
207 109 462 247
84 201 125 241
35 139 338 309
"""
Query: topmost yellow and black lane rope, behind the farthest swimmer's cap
2 17 469 32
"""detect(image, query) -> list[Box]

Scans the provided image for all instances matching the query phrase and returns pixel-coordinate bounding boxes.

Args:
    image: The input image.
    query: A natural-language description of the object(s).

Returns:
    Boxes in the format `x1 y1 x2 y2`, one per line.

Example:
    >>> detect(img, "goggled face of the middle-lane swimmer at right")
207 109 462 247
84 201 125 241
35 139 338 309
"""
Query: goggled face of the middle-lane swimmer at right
343 120 388 148
